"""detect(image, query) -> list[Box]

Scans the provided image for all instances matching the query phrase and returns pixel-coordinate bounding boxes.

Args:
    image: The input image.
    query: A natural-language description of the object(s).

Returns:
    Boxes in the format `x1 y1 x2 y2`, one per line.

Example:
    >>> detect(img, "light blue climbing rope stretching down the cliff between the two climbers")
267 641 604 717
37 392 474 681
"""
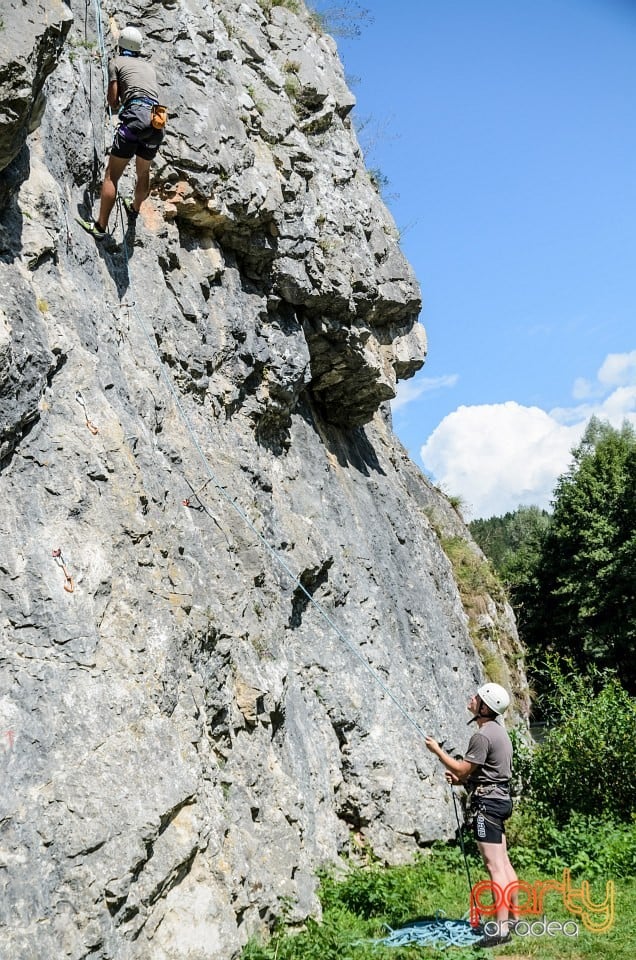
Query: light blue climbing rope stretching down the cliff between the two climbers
85 0 427 752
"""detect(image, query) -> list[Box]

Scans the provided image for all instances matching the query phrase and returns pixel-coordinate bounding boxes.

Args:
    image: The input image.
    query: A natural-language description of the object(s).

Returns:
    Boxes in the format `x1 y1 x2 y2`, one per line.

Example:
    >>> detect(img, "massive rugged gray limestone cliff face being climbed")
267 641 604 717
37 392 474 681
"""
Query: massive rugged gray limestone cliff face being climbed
0 0 527 960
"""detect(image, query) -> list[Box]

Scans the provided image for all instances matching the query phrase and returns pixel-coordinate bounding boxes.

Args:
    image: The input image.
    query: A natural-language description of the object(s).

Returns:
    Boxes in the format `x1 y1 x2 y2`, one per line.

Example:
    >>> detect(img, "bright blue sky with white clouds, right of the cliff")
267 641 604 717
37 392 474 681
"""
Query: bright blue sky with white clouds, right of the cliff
332 0 636 518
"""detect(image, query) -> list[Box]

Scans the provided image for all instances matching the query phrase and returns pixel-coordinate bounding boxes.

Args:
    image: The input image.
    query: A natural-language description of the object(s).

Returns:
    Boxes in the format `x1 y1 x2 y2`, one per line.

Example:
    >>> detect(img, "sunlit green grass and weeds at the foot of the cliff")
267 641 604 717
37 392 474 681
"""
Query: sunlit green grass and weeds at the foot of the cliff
242 844 636 960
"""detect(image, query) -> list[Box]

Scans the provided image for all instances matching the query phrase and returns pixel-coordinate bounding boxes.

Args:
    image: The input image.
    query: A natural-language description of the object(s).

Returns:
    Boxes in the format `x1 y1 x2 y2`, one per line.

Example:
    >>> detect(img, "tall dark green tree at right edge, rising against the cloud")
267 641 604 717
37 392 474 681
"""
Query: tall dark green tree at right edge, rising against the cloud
525 418 636 691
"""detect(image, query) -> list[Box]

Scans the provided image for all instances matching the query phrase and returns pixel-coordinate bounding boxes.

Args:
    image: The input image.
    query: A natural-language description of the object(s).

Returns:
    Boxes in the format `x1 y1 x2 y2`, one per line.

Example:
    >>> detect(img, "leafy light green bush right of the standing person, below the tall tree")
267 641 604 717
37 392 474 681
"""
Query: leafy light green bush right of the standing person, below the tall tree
529 660 636 823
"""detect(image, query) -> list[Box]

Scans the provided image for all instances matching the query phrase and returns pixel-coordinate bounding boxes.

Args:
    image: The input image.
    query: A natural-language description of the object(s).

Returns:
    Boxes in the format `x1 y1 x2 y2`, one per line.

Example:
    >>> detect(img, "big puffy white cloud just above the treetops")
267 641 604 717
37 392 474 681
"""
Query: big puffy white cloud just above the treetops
421 351 636 517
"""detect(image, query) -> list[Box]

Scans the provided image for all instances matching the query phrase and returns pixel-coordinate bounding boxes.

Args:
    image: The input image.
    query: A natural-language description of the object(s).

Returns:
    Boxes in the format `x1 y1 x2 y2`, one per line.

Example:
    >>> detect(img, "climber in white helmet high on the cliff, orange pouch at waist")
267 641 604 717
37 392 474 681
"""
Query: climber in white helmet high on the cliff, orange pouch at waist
78 26 166 240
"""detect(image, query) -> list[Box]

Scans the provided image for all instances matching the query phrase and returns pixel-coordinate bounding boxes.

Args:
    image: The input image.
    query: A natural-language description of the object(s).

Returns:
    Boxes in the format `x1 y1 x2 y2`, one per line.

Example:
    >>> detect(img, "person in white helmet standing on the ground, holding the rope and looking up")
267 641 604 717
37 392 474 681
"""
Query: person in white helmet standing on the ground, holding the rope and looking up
425 683 517 947
